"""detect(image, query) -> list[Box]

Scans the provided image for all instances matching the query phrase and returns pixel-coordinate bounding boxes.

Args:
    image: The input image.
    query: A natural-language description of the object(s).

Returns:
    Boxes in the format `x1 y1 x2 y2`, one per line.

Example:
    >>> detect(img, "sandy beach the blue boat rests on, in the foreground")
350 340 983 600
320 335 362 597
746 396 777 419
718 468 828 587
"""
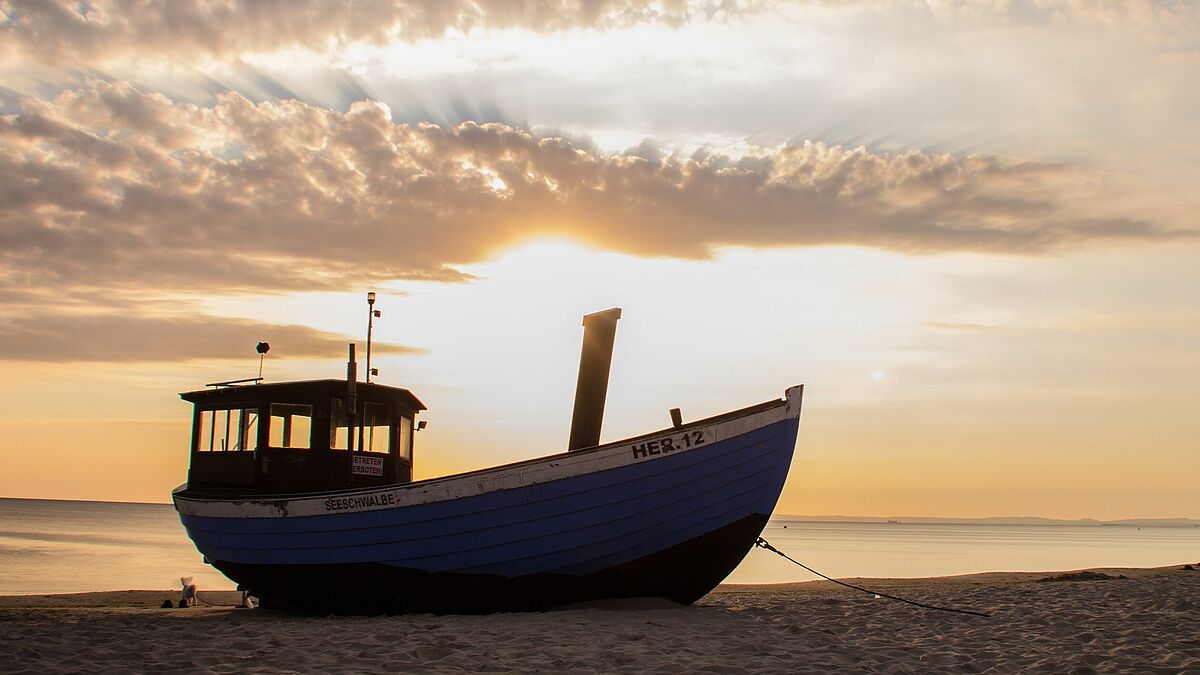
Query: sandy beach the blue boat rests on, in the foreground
0 565 1200 673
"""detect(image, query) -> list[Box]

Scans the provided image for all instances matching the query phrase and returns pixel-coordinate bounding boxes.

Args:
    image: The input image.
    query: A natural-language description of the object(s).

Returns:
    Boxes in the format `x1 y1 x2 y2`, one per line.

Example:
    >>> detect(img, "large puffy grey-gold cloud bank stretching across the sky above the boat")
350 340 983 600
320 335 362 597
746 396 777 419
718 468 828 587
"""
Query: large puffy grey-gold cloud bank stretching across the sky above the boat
0 82 1190 292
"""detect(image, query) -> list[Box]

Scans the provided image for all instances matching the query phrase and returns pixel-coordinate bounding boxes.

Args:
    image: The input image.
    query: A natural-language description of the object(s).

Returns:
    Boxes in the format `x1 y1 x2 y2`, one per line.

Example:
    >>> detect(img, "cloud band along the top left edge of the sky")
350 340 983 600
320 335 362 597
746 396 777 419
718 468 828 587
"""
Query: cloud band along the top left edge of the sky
0 0 758 65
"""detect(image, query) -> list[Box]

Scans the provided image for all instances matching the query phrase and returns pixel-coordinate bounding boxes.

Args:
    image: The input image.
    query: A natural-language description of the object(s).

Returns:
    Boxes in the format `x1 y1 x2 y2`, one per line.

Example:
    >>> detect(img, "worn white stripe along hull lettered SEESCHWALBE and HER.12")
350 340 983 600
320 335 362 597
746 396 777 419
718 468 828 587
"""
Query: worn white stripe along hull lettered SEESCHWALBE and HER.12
173 387 802 518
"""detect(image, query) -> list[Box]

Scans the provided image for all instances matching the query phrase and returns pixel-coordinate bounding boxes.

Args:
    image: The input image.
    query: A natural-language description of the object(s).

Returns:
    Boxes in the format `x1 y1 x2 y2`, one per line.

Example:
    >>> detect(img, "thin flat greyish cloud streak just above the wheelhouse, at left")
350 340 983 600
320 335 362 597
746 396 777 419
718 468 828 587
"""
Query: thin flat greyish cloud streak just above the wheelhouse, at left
0 312 422 363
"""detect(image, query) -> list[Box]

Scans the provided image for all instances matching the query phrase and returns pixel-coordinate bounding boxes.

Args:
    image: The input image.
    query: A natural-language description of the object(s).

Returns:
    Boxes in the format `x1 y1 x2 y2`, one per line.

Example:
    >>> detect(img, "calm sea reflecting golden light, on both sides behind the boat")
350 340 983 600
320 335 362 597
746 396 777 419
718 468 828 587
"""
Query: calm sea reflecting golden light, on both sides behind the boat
0 498 1200 596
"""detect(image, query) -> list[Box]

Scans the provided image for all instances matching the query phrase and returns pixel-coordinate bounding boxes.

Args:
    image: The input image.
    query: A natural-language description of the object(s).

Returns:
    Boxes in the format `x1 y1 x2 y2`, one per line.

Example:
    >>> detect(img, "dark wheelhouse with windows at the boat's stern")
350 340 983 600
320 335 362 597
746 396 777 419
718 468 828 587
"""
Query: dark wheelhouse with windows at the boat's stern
180 380 425 495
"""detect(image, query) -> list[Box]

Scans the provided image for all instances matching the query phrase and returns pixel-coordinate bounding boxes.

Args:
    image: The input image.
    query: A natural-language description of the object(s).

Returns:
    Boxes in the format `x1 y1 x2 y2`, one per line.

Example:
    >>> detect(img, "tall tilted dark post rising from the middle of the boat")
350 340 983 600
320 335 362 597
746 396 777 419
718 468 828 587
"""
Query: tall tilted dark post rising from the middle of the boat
566 307 620 450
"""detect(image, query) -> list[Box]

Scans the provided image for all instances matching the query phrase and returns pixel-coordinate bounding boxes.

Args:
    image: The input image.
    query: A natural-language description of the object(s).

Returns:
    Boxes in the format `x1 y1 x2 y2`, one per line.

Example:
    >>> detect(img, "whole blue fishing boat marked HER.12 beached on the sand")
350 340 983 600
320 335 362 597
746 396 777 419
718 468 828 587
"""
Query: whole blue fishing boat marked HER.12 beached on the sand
172 307 803 614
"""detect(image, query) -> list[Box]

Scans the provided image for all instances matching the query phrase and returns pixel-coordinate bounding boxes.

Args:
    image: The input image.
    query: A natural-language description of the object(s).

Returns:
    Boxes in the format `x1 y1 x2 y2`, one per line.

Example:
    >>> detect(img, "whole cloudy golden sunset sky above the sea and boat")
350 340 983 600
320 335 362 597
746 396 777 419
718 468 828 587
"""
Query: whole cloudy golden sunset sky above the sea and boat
0 0 1200 519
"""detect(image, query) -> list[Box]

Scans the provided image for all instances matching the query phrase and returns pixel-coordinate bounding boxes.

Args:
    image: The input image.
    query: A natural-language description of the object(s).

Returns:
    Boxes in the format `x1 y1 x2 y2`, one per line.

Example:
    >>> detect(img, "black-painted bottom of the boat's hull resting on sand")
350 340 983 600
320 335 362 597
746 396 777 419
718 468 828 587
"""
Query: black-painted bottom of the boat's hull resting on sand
212 514 767 614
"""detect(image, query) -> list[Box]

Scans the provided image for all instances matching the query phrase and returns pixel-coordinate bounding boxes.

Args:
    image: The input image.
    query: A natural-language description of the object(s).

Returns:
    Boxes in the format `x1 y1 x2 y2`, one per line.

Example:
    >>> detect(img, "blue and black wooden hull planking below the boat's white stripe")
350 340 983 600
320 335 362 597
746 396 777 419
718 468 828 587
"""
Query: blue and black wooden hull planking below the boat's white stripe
176 389 799 613
